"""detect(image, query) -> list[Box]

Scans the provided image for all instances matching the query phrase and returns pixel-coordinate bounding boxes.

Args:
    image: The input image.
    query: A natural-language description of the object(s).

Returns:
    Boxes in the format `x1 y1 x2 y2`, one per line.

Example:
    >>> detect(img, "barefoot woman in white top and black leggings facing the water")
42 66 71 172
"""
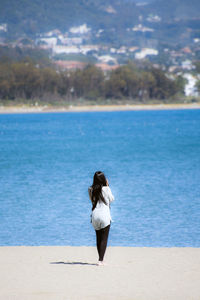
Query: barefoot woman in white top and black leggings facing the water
88 171 114 266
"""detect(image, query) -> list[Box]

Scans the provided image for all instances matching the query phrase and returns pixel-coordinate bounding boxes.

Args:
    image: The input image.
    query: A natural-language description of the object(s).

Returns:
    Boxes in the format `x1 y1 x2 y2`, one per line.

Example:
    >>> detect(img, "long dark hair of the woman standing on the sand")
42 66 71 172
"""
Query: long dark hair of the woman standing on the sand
91 171 107 210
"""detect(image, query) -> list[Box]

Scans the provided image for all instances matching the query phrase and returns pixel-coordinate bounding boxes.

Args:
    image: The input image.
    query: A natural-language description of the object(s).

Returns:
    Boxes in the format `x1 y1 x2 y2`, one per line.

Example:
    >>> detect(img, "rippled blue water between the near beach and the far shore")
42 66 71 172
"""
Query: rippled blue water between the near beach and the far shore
0 110 200 247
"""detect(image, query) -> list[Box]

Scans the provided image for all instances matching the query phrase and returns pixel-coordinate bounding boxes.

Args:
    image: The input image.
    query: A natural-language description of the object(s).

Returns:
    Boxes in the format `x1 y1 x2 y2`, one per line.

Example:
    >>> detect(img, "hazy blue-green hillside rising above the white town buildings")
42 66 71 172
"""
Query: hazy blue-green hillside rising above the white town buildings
0 0 200 47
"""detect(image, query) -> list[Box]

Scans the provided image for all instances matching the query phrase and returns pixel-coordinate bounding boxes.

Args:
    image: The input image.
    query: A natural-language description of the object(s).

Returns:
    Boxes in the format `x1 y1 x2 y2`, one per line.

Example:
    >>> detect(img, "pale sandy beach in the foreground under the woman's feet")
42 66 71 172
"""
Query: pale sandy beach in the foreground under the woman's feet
0 246 200 300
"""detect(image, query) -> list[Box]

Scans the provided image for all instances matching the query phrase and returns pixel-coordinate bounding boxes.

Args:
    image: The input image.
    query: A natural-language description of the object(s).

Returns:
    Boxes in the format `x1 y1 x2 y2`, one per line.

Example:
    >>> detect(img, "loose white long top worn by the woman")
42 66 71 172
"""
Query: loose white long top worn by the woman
88 186 114 230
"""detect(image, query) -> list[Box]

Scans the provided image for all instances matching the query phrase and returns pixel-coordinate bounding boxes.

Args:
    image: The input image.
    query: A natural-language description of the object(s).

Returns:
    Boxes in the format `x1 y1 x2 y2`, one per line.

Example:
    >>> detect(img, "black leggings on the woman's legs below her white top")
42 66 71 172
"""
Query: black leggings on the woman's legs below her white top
96 225 110 261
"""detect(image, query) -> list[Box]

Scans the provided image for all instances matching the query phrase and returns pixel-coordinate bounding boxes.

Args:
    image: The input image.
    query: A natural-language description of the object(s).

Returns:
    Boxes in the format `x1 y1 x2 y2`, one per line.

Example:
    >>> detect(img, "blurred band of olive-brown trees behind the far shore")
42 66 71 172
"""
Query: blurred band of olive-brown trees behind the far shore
0 60 184 101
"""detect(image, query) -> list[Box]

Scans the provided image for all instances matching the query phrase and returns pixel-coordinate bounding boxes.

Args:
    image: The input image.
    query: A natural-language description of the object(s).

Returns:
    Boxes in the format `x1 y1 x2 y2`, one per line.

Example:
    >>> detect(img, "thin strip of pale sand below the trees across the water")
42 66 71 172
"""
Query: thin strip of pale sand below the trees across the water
0 103 200 114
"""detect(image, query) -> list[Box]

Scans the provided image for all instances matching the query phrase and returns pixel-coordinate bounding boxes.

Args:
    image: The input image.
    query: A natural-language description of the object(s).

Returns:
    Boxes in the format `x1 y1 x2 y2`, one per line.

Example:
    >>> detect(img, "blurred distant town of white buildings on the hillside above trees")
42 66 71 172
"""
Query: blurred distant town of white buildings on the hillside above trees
0 17 200 97
